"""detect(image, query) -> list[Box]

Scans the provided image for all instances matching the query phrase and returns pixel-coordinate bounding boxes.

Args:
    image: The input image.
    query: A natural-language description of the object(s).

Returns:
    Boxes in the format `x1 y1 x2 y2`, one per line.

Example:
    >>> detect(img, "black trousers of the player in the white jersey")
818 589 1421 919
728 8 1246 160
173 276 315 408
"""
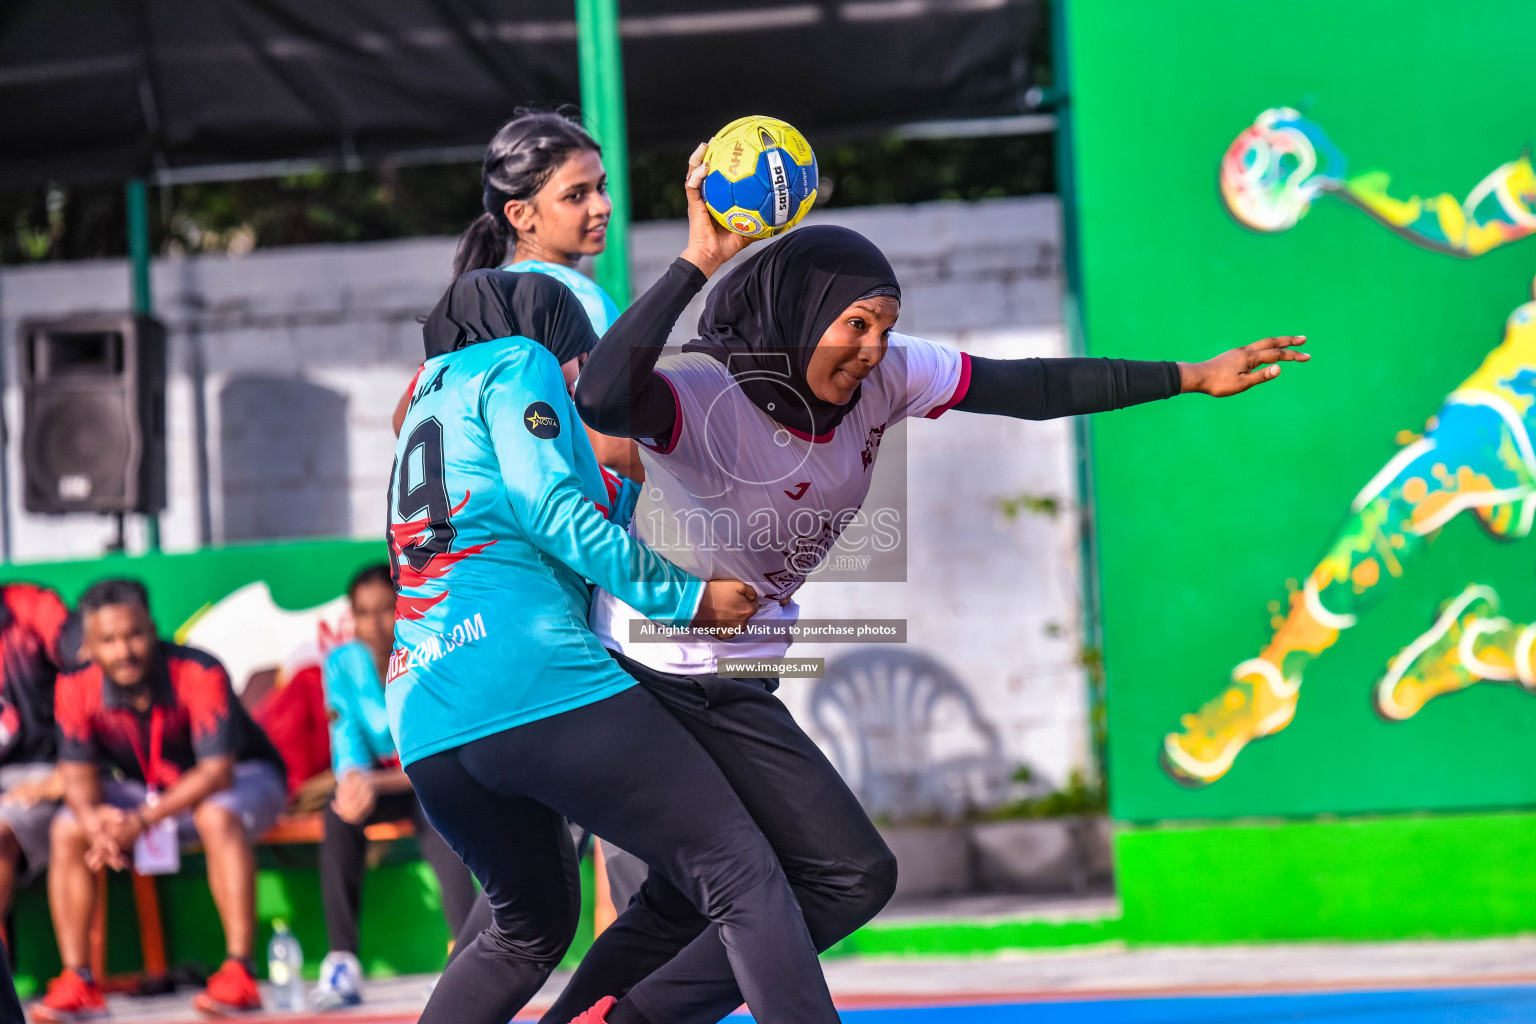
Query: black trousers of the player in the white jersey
541 654 895 1024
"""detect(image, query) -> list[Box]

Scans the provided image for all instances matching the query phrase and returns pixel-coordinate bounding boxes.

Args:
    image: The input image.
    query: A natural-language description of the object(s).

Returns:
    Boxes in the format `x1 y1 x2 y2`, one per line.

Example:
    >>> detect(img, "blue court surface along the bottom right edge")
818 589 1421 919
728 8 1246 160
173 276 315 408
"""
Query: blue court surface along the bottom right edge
731 986 1536 1024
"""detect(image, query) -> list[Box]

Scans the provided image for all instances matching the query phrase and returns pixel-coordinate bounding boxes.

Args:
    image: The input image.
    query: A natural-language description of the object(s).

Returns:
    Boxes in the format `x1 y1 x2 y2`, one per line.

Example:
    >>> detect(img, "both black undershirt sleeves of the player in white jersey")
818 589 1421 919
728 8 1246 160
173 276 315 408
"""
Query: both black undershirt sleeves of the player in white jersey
576 258 1181 438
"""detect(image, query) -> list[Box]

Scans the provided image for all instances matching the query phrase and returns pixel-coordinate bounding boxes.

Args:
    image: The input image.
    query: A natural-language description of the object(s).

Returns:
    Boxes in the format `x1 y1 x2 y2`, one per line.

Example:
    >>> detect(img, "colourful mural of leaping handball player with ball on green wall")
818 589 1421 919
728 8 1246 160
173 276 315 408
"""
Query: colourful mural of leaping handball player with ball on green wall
1161 107 1536 785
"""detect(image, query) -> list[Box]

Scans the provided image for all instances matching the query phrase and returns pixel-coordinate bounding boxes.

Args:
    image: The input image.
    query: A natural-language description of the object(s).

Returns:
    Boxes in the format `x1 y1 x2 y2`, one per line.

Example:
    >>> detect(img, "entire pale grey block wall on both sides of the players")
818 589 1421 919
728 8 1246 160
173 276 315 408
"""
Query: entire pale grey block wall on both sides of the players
0 197 1087 798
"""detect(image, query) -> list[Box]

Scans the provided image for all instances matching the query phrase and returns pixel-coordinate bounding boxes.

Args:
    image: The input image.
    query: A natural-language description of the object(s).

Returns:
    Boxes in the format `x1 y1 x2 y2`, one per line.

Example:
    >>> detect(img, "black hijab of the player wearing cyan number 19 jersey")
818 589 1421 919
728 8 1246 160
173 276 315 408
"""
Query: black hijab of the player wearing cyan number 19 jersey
421 270 598 362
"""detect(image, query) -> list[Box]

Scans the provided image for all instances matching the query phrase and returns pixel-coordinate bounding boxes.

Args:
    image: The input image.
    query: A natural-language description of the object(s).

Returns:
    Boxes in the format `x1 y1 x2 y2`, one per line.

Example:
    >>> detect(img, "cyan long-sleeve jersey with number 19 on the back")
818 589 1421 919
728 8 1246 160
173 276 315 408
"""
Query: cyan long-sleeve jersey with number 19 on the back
386 338 703 765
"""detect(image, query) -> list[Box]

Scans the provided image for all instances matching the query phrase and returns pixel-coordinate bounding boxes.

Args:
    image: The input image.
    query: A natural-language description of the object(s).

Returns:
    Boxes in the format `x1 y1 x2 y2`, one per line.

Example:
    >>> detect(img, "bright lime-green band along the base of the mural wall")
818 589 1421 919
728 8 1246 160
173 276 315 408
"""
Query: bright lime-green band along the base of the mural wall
1115 812 1536 944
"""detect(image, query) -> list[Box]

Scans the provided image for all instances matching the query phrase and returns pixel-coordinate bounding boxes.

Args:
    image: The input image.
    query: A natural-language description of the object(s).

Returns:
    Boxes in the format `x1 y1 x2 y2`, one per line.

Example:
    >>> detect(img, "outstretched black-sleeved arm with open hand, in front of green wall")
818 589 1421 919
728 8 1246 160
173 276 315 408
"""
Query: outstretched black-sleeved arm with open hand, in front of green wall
954 336 1310 419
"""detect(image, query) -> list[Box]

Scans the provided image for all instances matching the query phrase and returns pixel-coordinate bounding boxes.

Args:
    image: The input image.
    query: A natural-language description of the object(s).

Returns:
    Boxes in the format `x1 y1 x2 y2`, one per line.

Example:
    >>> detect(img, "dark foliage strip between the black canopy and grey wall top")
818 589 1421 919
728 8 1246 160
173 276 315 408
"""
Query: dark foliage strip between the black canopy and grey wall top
0 135 1055 264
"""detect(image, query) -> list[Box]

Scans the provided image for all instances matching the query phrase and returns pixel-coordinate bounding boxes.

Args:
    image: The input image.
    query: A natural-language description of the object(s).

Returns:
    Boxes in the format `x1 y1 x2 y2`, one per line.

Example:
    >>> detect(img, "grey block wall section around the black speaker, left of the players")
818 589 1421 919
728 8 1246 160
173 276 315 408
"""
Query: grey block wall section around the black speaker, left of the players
0 238 455 560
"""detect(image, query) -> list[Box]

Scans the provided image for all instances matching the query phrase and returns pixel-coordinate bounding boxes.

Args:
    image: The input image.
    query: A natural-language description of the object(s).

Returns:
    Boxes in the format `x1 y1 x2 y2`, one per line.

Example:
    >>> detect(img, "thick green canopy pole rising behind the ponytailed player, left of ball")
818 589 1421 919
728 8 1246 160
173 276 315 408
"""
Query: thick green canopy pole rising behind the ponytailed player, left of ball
576 0 630 309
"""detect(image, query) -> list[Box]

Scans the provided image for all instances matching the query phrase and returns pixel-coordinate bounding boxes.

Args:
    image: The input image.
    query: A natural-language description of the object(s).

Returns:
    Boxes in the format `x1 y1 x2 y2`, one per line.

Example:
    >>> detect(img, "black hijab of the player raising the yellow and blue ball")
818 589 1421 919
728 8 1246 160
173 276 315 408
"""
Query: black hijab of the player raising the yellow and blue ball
684 224 902 436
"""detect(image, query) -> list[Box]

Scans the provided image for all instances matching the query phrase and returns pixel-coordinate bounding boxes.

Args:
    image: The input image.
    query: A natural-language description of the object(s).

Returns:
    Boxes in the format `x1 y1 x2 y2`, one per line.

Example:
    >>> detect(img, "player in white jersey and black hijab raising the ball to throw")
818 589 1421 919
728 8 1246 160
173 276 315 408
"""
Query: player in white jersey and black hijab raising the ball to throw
544 147 1307 1024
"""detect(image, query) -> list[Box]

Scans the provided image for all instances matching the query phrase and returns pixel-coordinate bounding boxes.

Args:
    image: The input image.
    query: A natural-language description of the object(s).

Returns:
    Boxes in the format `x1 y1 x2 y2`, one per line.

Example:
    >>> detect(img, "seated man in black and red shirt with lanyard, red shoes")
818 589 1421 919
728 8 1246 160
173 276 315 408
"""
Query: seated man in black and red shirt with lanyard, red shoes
34 579 287 1021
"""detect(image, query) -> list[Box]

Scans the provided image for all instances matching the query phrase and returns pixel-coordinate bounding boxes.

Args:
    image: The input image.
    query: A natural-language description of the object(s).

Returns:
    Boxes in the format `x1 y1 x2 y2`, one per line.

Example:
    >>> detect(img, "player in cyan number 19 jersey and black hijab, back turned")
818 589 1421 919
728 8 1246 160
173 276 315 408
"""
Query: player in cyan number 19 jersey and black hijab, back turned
386 270 837 1024
